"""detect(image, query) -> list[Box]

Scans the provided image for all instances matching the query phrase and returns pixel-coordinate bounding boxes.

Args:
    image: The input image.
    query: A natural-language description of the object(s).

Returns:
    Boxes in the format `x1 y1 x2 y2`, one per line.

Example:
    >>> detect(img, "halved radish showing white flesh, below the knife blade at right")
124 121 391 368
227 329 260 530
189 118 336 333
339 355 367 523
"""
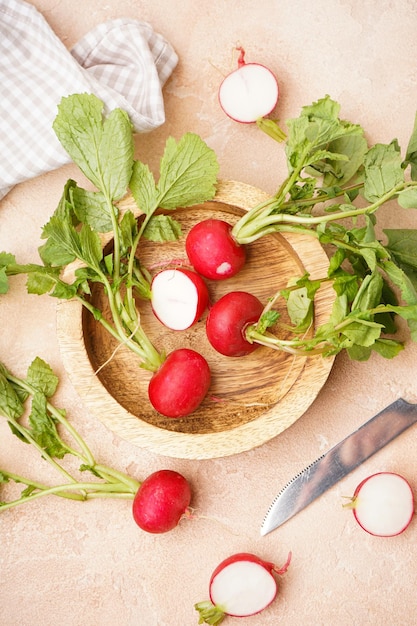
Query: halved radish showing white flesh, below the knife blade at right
347 472 414 537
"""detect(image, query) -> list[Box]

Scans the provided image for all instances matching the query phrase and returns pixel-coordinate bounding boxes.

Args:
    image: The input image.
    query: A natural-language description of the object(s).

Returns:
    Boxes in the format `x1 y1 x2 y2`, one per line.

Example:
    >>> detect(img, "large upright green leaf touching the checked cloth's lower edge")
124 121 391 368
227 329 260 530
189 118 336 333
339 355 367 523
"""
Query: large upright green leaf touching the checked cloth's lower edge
53 94 134 200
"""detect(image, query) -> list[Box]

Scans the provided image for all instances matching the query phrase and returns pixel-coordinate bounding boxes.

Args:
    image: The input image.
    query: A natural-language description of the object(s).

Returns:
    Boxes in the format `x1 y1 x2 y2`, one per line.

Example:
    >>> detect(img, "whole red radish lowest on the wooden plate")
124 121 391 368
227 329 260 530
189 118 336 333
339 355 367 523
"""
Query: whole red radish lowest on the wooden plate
148 348 211 417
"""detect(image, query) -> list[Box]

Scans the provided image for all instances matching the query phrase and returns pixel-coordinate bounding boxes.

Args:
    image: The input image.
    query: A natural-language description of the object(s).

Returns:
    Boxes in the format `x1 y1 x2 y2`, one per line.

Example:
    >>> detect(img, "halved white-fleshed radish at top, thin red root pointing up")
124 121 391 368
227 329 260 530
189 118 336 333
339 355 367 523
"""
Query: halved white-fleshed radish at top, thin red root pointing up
219 47 279 124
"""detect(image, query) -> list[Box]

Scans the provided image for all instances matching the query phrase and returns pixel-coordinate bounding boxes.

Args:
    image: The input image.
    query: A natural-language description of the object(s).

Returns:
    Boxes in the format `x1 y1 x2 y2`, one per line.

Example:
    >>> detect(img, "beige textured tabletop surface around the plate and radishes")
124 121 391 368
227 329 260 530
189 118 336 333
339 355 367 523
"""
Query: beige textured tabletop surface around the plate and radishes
0 0 417 626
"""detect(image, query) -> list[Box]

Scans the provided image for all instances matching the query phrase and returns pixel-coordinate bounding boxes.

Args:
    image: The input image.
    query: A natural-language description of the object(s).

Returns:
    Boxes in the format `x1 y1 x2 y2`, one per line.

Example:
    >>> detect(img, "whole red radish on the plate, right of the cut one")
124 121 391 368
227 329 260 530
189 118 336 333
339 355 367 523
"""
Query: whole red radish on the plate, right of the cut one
206 291 264 356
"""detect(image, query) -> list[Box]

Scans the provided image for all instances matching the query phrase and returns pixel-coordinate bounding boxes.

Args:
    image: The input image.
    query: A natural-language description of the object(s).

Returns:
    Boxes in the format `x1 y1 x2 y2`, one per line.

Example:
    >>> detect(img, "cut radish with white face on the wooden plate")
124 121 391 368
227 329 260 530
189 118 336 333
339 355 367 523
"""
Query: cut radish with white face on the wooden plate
151 268 209 330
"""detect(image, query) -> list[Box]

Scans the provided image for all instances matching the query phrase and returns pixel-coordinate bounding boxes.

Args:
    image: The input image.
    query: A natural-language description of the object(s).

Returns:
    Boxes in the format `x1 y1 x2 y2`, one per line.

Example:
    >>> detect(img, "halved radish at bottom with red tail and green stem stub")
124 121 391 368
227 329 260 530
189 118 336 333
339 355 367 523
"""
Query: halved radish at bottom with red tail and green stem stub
194 552 291 624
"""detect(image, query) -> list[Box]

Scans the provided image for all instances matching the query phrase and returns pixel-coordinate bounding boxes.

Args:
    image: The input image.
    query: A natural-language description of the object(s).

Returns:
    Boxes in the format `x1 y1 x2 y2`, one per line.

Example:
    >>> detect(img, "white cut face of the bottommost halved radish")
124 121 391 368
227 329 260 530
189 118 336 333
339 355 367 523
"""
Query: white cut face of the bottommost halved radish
210 561 277 617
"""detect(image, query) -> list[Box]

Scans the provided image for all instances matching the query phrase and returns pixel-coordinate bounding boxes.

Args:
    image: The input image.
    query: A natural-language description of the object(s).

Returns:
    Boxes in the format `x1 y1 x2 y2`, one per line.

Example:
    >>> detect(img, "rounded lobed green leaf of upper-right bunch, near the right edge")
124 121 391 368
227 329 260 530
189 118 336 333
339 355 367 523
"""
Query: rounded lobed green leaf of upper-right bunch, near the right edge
364 139 404 202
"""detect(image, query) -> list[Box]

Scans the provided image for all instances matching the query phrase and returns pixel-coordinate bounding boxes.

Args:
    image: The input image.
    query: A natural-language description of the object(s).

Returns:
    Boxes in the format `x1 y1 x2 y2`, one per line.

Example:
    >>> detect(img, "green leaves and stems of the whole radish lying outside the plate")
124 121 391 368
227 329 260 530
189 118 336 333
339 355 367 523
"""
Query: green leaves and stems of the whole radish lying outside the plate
0 357 141 511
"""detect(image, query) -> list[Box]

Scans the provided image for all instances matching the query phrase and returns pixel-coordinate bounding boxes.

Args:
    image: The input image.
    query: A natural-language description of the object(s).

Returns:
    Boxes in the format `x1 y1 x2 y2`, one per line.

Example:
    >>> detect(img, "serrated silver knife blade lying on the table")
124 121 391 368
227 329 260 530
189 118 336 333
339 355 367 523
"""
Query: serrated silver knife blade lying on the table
261 398 417 536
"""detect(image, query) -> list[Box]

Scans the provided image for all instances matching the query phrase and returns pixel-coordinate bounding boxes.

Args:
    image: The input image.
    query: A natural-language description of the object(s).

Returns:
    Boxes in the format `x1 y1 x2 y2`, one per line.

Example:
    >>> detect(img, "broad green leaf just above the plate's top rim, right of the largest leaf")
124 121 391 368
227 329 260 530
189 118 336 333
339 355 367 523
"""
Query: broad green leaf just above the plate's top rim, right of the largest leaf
158 133 219 209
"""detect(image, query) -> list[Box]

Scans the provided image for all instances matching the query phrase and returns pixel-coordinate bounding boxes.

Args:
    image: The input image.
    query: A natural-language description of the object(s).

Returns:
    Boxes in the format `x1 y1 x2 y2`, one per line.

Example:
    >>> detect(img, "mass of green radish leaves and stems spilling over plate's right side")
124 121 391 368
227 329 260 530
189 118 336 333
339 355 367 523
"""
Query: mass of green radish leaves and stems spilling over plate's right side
232 96 417 360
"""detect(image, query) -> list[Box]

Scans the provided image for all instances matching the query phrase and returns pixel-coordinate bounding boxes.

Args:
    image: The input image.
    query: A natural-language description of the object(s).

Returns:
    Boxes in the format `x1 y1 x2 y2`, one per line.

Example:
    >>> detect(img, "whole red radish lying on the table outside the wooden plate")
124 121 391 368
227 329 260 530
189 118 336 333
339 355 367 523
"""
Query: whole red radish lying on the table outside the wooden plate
132 470 191 533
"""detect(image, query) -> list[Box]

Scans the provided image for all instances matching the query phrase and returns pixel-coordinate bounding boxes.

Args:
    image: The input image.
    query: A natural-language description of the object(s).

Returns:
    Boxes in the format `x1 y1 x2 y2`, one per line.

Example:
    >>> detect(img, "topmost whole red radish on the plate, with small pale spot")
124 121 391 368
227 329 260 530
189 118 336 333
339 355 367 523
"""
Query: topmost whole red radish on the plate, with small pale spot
185 219 246 280
